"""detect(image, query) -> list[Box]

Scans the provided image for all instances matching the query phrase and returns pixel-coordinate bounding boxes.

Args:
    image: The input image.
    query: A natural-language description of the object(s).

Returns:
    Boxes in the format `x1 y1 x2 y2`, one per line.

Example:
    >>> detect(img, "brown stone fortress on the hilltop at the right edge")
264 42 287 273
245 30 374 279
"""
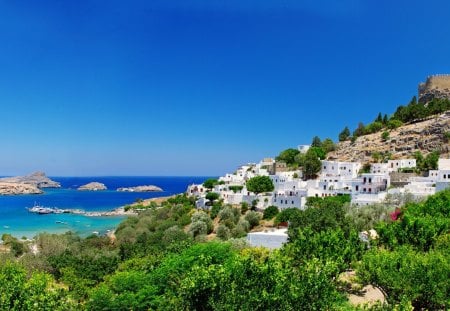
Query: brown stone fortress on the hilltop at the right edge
419 74 450 104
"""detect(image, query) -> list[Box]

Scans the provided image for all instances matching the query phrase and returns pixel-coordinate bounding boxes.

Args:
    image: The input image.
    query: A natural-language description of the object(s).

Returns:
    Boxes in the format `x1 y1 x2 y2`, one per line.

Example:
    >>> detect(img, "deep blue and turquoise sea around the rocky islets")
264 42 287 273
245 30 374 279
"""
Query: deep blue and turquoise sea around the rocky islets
0 176 209 239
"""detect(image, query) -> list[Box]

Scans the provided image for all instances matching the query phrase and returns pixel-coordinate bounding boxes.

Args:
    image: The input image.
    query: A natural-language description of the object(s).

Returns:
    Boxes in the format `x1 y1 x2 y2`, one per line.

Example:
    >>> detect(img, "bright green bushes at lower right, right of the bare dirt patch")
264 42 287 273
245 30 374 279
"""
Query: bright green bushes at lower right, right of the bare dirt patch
358 190 450 310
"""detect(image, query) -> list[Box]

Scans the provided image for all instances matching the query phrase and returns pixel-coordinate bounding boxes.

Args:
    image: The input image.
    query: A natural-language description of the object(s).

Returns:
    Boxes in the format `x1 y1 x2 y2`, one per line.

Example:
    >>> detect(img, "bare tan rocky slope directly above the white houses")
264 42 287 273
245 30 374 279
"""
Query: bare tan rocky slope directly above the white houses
328 111 450 163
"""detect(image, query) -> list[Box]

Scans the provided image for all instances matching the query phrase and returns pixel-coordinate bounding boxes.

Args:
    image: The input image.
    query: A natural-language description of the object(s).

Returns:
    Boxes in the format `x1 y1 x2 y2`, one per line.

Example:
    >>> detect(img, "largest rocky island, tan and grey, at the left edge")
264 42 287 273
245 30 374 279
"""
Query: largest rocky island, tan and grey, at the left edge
0 172 61 195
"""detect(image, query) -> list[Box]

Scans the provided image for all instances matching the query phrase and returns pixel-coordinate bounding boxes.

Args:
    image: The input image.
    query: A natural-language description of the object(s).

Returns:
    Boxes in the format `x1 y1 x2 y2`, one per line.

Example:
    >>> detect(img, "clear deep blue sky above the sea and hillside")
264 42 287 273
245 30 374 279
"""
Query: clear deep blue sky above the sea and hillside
0 0 450 176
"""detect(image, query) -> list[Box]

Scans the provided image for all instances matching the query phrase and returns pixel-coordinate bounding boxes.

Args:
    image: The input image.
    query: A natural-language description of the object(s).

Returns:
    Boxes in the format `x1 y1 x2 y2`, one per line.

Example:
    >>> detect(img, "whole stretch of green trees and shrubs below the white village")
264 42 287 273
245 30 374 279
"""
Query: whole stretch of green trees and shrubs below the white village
0 190 450 310
